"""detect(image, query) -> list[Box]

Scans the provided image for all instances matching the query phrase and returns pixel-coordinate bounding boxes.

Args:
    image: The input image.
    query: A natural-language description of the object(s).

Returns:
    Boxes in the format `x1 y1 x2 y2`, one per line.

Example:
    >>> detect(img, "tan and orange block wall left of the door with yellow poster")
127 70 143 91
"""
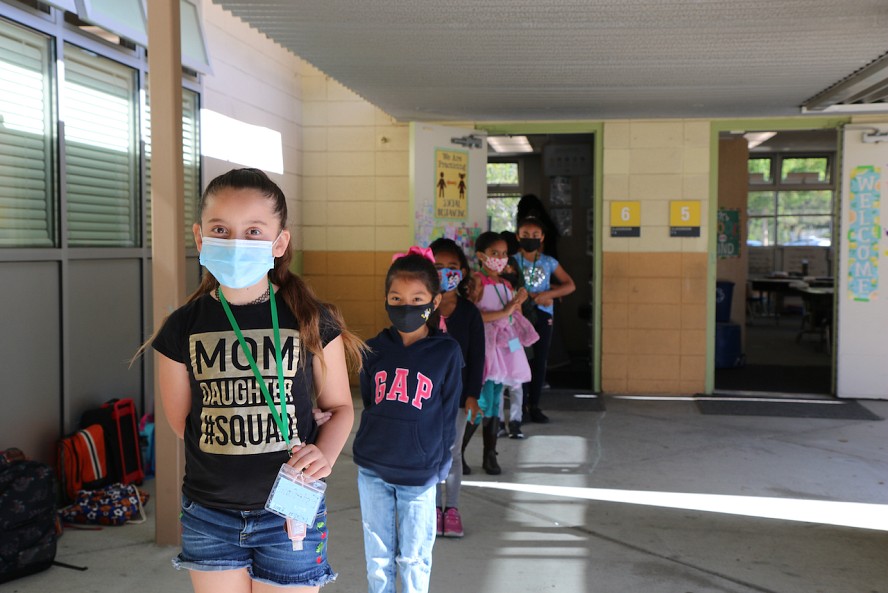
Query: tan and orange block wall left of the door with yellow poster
298 64 413 339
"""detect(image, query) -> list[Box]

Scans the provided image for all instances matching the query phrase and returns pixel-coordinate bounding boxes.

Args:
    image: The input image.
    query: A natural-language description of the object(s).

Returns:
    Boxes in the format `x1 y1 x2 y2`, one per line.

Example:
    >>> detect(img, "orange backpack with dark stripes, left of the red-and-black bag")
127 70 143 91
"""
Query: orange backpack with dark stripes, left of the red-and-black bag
56 424 111 500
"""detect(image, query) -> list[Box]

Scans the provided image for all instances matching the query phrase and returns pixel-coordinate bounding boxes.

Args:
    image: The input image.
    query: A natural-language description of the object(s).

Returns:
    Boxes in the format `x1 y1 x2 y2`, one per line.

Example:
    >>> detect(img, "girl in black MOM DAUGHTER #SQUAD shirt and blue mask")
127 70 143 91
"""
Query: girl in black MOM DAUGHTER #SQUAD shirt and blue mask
151 169 363 593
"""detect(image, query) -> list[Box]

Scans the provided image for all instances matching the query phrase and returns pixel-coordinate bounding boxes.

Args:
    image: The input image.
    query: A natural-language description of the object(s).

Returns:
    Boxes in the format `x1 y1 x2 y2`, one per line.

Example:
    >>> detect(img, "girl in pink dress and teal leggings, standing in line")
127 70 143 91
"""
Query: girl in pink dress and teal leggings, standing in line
463 231 538 475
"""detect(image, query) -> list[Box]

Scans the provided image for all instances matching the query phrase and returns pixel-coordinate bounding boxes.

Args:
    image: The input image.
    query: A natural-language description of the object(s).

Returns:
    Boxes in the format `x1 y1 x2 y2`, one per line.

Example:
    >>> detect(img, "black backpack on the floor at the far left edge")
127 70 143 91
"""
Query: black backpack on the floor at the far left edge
0 449 58 583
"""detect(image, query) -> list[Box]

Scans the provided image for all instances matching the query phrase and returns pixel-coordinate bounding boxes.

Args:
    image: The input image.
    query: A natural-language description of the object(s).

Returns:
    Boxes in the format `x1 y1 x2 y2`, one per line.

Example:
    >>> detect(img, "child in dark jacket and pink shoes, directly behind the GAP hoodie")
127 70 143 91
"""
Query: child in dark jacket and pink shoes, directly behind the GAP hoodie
429 238 484 537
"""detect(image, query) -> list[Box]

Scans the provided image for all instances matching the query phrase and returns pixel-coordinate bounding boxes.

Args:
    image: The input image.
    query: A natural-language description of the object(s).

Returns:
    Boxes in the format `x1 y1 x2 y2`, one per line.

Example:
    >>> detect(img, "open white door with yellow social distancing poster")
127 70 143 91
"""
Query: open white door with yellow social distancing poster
410 122 487 251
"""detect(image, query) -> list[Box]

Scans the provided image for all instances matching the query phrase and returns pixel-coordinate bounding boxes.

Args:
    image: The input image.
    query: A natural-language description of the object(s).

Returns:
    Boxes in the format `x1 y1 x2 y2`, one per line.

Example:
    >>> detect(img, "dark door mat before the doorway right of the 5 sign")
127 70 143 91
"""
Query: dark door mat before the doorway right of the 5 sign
696 398 882 420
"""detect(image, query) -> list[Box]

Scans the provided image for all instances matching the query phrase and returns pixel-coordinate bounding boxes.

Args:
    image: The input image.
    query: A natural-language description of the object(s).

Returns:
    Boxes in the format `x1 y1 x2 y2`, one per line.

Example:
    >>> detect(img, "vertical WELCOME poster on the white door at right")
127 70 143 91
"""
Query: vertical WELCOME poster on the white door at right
848 165 881 303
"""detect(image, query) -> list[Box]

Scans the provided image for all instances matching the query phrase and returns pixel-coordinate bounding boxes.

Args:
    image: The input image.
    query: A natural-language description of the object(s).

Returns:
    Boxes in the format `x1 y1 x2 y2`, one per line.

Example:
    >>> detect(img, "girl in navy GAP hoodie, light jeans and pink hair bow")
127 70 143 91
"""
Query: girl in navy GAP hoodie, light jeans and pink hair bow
353 247 463 593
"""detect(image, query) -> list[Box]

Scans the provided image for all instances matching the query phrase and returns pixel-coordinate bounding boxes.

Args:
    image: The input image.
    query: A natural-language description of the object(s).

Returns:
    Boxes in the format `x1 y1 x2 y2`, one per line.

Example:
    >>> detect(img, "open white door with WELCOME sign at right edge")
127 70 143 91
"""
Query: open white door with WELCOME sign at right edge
836 124 888 399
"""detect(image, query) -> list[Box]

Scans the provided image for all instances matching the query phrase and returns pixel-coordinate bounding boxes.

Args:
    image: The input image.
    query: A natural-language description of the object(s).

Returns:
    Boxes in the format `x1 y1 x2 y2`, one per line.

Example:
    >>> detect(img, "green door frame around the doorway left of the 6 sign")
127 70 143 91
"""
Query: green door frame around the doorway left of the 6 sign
475 122 604 393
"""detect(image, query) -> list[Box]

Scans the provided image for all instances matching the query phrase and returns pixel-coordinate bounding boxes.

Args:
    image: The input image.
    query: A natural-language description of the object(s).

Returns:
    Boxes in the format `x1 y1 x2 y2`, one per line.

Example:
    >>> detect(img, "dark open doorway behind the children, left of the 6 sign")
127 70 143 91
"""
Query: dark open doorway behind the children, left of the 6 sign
487 133 595 390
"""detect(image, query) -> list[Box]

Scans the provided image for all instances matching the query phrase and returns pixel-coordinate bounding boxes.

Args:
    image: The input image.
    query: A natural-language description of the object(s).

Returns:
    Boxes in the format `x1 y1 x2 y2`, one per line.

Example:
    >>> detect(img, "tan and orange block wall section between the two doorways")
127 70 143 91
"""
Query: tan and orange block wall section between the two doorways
601 120 710 395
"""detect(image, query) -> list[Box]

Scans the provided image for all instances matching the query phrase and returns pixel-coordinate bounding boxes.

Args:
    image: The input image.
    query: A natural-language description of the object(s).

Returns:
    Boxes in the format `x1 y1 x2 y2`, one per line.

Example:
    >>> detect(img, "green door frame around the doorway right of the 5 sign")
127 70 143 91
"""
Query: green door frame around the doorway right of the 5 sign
705 116 851 394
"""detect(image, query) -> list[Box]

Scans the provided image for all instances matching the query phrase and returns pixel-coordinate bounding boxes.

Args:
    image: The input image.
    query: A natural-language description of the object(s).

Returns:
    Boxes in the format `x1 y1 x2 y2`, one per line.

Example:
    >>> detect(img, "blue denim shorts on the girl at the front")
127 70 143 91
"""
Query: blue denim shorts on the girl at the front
173 495 336 587
